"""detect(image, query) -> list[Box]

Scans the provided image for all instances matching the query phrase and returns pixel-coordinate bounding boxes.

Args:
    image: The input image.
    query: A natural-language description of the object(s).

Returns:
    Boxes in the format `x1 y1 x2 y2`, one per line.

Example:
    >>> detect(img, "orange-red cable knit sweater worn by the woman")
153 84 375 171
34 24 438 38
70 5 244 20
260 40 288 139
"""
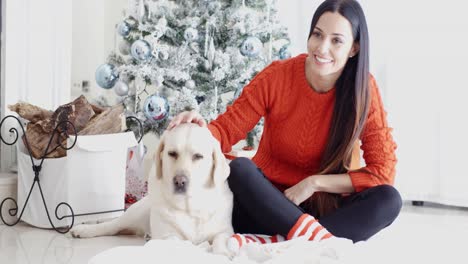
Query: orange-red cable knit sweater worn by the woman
208 54 396 192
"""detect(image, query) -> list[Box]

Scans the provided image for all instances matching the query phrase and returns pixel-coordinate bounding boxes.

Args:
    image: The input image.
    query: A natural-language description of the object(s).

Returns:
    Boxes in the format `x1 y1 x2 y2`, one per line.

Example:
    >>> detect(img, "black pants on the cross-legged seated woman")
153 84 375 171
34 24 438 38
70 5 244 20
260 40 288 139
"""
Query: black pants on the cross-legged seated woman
228 158 402 242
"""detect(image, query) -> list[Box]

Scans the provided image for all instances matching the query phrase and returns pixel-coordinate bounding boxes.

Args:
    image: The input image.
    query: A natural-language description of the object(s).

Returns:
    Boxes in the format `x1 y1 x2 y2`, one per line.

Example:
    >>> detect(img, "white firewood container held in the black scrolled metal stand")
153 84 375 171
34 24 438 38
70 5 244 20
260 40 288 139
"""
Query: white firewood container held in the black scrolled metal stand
17 132 138 228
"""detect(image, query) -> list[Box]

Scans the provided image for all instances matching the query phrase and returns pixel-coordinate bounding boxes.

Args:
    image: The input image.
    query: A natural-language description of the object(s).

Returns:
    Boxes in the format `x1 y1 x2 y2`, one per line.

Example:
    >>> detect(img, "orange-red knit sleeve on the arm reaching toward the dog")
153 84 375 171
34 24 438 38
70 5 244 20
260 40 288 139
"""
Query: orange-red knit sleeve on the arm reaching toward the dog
208 62 277 153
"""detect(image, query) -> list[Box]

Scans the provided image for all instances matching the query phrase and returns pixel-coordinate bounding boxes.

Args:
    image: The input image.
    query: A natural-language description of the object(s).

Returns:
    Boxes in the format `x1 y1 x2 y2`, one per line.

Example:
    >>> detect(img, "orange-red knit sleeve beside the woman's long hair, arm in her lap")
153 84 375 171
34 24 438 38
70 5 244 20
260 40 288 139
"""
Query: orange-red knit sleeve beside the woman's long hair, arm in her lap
348 75 397 192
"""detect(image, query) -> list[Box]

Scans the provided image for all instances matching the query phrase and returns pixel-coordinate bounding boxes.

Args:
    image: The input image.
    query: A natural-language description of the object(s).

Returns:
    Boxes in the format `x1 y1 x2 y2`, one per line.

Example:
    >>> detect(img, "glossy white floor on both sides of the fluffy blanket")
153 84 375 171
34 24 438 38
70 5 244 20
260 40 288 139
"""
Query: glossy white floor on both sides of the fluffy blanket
0 202 468 264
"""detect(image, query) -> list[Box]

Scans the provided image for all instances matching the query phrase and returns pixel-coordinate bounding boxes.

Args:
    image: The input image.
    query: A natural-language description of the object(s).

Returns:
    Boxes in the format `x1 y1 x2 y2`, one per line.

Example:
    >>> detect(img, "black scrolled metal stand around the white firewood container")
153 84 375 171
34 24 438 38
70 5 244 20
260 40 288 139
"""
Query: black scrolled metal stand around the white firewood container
0 115 143 234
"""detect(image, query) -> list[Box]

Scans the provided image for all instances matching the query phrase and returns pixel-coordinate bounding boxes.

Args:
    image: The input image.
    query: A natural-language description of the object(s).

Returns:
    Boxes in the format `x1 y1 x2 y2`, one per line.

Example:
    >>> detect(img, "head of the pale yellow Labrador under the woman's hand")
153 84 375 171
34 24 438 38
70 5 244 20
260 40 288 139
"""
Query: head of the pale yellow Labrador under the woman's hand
155 124 229 198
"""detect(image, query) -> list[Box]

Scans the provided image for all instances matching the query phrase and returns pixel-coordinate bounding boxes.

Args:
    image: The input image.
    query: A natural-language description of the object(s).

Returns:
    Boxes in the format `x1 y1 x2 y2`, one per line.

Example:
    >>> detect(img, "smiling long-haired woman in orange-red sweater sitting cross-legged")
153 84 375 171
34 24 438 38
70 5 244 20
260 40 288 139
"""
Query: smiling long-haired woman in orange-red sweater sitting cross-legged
168 0 402 246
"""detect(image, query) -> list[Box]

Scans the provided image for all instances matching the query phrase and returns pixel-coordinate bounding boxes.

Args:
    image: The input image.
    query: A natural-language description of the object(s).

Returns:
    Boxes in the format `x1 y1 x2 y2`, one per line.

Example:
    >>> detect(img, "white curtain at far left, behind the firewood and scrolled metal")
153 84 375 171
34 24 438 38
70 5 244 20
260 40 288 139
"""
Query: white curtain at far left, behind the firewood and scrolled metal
1 0 72 173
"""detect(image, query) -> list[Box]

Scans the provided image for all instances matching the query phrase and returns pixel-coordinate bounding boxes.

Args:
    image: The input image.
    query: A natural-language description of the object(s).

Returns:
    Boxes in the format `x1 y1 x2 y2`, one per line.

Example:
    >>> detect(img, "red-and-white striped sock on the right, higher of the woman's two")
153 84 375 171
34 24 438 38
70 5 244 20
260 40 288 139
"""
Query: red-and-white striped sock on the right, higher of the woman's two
287 214 333 241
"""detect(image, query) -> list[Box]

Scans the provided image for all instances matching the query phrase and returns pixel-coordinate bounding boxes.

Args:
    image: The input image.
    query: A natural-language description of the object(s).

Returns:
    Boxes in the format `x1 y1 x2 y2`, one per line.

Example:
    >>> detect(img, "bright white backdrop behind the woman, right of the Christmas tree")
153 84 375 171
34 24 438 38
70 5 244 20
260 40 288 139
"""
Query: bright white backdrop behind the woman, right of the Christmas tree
277 0 468 206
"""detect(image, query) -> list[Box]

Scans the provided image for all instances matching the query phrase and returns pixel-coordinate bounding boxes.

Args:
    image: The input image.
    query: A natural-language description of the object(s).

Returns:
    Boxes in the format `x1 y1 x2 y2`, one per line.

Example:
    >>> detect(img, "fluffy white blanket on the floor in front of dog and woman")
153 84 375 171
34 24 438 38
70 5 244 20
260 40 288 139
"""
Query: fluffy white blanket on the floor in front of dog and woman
89 239 368 264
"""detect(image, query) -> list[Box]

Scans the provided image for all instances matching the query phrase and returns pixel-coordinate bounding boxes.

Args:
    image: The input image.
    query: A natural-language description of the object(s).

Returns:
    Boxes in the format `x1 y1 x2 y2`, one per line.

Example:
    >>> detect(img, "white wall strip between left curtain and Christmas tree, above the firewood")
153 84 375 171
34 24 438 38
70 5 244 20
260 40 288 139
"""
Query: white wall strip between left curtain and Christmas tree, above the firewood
71 0 128 103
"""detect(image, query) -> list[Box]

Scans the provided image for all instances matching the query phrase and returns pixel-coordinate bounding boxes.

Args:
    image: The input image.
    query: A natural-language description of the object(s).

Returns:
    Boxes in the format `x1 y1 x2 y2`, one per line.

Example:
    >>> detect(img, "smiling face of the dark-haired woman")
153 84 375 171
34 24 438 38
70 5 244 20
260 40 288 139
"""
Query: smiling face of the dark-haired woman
307 12 359 78
